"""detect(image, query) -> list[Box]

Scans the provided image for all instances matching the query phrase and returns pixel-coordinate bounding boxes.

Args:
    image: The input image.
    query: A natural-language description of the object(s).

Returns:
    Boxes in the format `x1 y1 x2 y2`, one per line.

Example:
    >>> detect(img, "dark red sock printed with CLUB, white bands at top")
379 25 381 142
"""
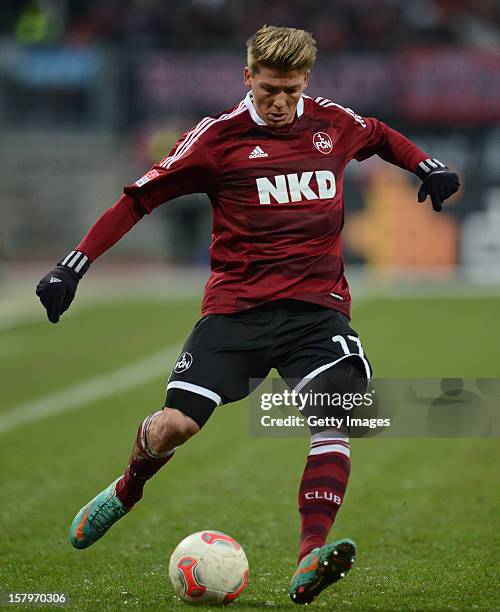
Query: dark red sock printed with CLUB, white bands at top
299 431 351 562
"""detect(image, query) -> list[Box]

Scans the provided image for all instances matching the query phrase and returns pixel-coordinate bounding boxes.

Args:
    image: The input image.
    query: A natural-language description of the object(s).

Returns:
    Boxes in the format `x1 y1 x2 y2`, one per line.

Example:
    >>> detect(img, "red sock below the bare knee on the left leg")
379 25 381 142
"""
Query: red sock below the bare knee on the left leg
115 412 175 508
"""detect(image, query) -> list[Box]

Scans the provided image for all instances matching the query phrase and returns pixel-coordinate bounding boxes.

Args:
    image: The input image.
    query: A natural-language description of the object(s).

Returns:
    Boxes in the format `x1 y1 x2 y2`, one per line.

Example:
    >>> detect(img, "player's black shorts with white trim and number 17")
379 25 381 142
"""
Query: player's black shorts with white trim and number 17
165 300 371 426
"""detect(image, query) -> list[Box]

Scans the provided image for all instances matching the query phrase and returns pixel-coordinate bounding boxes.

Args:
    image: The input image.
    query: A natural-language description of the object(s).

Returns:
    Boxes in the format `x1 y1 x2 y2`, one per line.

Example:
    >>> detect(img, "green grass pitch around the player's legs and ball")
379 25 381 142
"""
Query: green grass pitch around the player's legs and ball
0 297 500 610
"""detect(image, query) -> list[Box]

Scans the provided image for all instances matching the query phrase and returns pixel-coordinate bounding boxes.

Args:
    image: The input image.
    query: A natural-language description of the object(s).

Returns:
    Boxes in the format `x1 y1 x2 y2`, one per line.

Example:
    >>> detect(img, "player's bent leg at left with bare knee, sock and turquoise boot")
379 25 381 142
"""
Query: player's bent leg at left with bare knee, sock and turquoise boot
70 315 268 548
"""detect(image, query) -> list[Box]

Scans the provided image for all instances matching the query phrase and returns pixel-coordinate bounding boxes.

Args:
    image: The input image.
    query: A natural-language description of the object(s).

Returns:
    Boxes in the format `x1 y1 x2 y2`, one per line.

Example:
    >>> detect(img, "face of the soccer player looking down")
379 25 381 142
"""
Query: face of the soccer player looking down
244 67 309 127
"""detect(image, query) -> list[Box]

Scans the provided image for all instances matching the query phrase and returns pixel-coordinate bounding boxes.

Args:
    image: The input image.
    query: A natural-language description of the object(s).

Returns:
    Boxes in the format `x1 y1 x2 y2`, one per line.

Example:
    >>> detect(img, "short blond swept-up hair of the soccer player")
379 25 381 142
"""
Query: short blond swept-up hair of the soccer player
247 25 317 74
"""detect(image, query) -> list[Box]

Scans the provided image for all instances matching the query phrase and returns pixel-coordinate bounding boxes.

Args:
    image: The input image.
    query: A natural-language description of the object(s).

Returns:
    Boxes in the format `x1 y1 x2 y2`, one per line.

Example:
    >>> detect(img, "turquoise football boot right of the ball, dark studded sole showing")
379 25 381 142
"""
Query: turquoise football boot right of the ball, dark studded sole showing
288 538 356 604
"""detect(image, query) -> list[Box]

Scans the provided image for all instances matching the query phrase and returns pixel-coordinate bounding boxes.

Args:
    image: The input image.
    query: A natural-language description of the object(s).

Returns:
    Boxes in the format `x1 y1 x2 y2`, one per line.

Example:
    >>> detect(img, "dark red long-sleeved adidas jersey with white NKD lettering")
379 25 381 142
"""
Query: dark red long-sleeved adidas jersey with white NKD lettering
76 94 428 316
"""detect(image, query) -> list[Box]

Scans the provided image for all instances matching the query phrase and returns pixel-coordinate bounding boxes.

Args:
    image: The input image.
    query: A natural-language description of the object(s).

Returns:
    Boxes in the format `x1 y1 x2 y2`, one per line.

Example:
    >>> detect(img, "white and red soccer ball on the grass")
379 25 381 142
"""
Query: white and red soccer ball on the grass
168 531 248 604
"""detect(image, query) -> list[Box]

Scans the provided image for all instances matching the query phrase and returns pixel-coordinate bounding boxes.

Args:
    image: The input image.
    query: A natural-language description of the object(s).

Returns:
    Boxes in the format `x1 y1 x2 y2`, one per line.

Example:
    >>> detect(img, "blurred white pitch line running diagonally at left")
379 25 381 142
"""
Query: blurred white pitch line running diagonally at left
0 345 180 435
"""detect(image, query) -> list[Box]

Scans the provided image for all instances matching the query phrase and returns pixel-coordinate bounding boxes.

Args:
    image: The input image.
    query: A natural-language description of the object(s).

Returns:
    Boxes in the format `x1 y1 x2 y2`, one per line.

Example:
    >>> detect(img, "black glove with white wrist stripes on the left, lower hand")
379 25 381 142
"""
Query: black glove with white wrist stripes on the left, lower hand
36 251 90 323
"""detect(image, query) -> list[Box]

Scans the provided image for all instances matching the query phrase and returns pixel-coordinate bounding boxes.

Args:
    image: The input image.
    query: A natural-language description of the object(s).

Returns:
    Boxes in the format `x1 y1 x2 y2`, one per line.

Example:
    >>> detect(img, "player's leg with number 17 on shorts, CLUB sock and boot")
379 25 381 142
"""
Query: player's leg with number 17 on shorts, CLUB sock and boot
278 305 371 603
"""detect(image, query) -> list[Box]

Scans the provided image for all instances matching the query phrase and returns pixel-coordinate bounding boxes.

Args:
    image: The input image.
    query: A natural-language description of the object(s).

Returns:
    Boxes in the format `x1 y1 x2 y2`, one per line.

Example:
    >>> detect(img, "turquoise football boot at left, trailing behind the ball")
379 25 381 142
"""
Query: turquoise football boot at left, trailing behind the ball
70 476 130 548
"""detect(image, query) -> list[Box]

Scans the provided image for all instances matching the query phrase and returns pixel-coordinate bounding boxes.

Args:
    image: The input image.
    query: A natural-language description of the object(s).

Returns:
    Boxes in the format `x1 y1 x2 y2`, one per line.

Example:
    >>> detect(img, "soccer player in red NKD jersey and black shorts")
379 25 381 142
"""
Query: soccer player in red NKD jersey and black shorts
37 26 460 604
